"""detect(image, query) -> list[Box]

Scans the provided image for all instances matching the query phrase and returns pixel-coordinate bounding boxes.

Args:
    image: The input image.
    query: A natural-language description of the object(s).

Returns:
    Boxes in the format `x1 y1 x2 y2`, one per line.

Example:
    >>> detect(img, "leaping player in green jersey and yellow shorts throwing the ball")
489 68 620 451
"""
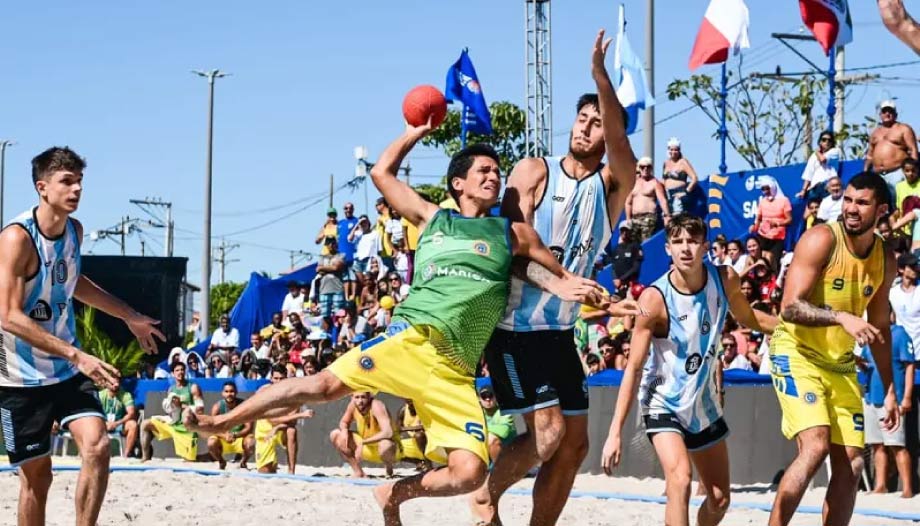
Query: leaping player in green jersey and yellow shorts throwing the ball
186 113 600 525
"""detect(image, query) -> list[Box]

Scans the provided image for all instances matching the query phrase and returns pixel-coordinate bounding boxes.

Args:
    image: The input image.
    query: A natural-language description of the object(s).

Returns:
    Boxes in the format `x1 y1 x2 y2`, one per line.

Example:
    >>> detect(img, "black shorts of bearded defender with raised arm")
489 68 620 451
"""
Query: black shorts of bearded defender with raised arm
485 329 588 416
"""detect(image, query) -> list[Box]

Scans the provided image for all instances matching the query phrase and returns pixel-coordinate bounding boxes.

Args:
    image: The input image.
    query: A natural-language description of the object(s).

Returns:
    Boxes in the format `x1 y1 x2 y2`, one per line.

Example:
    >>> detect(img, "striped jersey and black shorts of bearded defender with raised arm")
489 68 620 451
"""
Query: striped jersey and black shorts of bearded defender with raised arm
485 157 622 416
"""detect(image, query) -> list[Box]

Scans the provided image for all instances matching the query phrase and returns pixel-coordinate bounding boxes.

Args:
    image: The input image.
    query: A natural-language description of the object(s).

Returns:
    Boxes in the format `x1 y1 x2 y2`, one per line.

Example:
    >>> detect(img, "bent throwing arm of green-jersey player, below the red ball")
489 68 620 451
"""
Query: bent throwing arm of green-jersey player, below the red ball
371 123 438 231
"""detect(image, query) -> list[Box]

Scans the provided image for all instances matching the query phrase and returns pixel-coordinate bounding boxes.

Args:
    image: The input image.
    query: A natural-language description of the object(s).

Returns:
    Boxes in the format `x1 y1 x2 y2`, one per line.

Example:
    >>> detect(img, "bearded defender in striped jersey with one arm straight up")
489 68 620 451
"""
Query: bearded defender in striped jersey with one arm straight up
471 30 636 524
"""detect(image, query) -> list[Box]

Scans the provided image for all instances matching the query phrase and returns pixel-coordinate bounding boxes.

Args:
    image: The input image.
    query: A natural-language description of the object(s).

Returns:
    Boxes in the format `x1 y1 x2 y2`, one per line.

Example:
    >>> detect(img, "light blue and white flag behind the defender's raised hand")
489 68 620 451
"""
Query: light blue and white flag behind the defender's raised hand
613 4 655 134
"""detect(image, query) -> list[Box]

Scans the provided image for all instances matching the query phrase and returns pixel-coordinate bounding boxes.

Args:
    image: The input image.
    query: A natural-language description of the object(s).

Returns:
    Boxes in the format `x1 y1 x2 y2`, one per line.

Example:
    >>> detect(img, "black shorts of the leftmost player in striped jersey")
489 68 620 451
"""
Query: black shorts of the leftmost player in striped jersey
0 374 105 466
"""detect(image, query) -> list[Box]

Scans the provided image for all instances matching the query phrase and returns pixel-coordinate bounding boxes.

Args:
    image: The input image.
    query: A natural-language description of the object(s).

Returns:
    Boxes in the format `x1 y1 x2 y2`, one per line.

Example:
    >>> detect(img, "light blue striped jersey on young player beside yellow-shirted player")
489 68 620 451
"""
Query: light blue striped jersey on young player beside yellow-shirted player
639 263 728 433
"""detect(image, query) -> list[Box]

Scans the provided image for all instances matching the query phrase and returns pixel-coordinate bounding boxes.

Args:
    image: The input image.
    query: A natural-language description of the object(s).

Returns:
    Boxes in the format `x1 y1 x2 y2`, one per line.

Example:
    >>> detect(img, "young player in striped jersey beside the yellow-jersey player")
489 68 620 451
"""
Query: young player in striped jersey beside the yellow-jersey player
601 214 776 526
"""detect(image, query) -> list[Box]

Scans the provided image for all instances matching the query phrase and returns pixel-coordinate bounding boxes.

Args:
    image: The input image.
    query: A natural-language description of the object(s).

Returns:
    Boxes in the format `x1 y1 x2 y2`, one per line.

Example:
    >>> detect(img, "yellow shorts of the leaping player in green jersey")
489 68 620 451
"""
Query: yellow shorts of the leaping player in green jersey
328 322 489 464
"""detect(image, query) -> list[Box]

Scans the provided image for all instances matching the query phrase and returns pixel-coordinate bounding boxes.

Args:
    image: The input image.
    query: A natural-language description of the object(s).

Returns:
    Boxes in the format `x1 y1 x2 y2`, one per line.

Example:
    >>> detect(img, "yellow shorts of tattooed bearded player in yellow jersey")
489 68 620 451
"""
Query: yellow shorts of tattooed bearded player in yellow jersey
770 345 865 447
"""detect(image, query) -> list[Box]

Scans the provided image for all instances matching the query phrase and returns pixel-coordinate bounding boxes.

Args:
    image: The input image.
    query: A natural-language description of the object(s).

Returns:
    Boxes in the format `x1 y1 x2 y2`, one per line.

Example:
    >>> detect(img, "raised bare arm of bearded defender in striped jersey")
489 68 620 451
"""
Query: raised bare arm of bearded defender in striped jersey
591 29 636 221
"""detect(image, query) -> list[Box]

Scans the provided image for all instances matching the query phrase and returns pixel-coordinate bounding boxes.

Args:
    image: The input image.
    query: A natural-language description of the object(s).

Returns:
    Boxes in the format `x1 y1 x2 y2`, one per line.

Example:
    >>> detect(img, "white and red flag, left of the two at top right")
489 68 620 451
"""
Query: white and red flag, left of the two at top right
690 0 751 70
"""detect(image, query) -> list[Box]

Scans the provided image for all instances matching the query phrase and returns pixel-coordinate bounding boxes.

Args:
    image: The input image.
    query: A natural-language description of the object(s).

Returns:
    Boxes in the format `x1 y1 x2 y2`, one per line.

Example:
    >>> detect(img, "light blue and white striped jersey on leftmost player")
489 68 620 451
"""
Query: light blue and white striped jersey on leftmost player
0 209 80 387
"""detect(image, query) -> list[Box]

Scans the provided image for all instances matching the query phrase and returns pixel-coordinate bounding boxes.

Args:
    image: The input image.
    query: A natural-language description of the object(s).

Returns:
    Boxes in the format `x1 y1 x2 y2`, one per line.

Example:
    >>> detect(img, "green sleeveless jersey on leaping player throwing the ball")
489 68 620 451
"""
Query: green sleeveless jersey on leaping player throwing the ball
393 210 511 373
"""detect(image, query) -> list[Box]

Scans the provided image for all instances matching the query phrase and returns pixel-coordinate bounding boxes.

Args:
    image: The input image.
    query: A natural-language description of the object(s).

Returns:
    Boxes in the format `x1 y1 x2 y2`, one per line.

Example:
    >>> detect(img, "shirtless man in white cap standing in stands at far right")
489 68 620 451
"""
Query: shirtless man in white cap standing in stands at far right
864 100 917 206
